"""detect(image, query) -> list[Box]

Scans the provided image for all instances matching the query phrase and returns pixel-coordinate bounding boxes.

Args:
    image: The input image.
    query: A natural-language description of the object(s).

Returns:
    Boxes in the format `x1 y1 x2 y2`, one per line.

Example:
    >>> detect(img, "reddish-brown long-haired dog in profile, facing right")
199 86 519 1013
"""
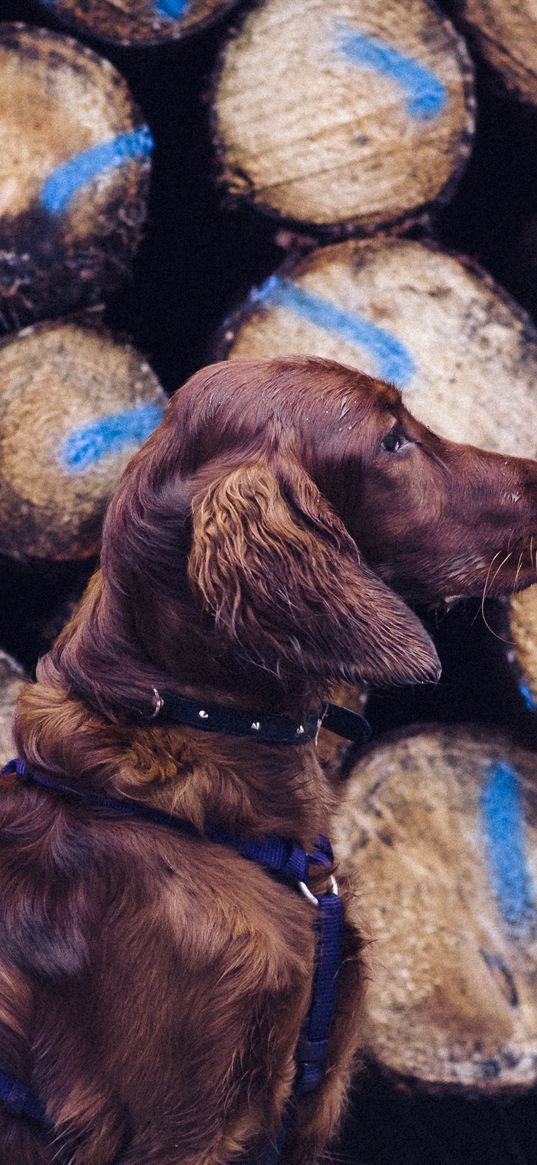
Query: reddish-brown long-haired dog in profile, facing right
0 359 537 1165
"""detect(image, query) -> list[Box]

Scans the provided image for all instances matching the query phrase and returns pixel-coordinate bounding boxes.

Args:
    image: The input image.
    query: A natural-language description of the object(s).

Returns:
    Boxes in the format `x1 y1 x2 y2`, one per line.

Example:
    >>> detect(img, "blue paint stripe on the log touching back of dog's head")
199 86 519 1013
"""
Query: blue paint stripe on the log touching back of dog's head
61 404 164 473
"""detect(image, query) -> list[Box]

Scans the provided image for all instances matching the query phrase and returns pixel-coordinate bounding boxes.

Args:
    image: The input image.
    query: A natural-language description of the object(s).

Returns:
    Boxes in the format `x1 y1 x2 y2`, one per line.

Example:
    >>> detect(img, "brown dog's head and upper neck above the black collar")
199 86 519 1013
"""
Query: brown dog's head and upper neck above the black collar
45 358 537 708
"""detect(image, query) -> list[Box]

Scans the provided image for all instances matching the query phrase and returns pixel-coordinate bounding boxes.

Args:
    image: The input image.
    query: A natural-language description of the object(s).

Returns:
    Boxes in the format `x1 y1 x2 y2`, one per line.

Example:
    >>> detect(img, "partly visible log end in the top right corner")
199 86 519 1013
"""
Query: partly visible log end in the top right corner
452 0 537 106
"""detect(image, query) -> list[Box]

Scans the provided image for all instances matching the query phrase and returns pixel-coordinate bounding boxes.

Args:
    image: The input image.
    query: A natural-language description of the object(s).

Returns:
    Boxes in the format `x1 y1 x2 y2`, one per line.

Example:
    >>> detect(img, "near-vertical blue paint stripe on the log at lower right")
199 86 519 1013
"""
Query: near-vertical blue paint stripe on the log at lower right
481 761 536 935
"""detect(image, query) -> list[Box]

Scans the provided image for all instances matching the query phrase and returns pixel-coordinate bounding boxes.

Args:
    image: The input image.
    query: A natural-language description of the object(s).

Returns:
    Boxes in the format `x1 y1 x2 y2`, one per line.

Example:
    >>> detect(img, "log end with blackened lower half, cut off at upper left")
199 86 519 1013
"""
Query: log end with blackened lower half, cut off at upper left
0 23 153 330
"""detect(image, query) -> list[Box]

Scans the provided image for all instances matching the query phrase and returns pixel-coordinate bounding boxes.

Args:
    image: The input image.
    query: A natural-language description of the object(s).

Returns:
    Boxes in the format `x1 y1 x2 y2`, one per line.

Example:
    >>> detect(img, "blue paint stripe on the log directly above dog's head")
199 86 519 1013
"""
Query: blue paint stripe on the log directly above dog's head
255 275 415 388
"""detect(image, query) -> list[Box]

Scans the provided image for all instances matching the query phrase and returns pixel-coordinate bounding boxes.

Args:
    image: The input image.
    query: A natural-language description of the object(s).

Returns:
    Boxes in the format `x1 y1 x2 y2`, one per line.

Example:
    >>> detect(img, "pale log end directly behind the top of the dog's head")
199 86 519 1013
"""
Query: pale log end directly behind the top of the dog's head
217 239 537 457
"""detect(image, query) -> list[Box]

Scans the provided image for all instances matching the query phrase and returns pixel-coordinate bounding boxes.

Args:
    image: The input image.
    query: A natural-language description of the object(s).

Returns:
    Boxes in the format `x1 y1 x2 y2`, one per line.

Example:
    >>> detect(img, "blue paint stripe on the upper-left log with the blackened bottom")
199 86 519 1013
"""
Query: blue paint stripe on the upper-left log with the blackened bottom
41 126 154 214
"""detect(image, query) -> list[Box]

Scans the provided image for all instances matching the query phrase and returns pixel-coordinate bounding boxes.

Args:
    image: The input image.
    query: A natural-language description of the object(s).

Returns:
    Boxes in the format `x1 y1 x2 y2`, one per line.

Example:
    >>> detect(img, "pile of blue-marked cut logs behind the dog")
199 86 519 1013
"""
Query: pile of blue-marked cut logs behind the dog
0 0 537 1165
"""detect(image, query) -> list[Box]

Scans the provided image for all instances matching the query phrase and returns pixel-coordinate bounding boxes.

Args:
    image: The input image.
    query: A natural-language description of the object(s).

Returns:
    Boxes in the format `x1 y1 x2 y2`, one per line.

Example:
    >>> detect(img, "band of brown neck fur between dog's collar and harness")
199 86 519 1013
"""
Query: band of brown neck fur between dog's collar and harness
15 684 333 847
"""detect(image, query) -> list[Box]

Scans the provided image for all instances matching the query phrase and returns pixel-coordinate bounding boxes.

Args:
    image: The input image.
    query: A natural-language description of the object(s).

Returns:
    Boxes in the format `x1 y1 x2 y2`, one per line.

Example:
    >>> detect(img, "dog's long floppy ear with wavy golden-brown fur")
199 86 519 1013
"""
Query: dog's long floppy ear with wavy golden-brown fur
189 452 439 684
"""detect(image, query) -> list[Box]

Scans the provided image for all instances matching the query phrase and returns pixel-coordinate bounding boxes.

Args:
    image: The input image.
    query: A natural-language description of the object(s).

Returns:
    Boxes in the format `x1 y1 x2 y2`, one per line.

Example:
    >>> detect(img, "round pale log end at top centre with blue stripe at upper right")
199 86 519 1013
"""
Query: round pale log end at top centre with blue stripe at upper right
213 0 474 238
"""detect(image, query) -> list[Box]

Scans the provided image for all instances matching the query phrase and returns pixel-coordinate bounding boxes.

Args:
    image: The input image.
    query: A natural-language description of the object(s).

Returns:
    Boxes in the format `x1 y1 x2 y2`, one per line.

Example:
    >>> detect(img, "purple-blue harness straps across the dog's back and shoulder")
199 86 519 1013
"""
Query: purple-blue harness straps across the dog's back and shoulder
0 754 342 1165
